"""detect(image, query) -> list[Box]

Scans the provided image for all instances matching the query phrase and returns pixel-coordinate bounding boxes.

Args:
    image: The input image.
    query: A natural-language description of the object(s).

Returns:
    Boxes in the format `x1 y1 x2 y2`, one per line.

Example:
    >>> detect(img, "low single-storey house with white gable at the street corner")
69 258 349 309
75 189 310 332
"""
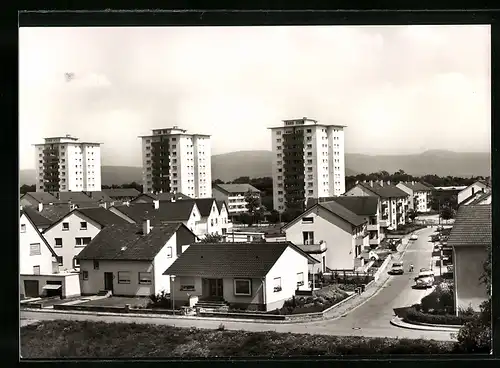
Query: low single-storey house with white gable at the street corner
163 242 318 311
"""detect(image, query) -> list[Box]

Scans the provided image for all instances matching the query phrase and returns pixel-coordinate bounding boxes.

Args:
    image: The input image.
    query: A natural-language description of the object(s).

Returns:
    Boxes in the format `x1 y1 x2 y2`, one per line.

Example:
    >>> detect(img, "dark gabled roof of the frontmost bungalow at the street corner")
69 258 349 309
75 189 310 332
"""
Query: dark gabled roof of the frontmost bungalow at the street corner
163 242 318 278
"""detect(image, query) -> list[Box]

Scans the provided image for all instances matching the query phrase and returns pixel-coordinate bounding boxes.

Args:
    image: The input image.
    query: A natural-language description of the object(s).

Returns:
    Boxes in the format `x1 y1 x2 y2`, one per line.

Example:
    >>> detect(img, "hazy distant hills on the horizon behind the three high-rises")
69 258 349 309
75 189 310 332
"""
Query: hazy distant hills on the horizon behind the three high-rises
20 150 491 185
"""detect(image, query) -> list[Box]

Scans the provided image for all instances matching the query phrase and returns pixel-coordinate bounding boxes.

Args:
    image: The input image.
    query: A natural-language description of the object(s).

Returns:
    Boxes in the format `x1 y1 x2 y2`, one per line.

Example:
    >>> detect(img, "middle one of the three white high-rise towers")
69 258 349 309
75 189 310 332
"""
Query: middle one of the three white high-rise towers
139 126 212 198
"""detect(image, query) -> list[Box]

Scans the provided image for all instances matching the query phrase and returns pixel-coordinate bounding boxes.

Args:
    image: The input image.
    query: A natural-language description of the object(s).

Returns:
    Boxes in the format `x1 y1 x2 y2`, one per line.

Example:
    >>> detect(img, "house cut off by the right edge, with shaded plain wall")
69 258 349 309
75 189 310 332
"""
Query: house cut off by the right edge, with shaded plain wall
448 205 492 314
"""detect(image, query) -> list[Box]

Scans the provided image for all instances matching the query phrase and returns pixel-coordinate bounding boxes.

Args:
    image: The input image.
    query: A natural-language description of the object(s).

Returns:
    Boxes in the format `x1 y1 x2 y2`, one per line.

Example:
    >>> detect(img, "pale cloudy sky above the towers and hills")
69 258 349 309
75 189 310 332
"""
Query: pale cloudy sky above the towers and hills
19 26 491 169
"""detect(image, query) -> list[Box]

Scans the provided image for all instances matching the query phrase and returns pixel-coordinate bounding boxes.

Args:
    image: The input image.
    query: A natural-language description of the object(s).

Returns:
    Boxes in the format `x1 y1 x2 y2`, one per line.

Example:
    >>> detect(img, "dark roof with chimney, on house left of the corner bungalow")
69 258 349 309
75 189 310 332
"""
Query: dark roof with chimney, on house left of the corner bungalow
77 223 184 261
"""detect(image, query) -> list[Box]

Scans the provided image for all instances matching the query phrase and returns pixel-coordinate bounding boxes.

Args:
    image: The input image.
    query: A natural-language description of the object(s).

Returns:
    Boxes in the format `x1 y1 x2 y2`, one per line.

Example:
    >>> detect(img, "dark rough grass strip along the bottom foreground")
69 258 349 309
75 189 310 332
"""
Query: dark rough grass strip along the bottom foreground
21 320 454 359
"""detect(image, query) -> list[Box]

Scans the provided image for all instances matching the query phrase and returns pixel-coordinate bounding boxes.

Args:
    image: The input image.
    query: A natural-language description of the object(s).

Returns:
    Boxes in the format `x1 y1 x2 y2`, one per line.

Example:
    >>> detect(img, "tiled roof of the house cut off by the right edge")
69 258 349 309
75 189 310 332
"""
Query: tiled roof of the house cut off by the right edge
448 205 491 247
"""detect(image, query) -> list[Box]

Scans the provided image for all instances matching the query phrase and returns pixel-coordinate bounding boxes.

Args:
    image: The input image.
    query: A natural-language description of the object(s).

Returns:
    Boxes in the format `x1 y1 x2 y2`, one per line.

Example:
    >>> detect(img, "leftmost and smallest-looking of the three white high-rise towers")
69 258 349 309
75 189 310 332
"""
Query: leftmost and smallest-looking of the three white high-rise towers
34 134 101 192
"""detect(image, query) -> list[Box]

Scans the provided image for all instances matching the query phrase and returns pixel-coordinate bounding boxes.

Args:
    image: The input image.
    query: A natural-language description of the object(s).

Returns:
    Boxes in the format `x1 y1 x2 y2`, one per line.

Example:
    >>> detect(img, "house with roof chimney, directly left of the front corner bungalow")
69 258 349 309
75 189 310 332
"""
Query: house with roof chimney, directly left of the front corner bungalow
77 220 196 297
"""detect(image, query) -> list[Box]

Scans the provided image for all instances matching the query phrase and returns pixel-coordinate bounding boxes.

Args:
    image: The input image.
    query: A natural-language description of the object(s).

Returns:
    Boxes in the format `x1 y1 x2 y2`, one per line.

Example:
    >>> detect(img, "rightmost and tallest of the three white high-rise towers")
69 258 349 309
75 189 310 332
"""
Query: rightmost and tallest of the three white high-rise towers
269 118 345 212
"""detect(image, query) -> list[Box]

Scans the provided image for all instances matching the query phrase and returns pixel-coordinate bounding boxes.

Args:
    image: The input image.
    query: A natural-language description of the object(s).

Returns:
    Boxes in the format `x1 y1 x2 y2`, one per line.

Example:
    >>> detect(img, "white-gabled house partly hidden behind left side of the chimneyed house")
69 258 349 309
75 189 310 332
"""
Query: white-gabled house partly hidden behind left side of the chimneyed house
43 207 128 270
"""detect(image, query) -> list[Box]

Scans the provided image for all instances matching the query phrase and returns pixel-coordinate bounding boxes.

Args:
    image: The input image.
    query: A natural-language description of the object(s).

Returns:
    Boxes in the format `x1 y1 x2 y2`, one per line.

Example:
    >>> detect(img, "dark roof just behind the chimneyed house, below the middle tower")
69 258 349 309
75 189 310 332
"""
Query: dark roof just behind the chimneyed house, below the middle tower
115 201 194 225
